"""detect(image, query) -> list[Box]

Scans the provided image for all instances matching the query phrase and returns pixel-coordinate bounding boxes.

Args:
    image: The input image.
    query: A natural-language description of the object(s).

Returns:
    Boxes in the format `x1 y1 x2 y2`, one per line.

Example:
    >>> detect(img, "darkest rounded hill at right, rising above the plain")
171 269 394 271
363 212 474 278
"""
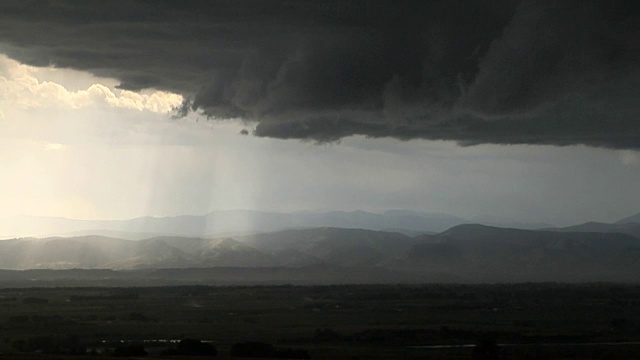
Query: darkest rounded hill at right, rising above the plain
384 225 640 281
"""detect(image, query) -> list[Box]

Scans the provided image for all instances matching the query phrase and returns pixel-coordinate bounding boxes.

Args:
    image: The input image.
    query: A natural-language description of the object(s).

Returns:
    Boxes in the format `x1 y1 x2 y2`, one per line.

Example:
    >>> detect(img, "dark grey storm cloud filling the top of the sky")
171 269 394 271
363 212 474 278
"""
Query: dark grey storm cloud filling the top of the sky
0 0 640 148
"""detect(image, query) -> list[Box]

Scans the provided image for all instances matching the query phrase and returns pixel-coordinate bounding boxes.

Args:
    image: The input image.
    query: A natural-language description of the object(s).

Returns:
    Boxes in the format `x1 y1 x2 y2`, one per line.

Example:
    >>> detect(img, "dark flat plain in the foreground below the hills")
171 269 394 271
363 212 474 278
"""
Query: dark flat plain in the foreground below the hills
0 284 640 359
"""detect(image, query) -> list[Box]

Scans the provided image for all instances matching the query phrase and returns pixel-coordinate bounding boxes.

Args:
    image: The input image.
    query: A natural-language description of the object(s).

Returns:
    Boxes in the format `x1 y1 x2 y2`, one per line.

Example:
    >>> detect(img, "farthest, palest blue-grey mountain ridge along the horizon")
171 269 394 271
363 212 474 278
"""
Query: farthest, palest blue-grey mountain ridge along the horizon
0 210 471 240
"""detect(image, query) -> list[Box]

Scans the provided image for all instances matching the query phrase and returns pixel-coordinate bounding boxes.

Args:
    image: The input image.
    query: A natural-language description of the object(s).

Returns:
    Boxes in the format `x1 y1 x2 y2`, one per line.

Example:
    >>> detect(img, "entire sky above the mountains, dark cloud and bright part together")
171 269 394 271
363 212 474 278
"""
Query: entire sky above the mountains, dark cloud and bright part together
0 1 640 224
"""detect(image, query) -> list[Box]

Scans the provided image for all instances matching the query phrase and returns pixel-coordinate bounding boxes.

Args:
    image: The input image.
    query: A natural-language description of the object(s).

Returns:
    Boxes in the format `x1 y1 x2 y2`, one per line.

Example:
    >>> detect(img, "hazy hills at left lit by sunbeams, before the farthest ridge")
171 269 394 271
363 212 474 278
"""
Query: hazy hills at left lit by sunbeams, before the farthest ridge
0 228 420 270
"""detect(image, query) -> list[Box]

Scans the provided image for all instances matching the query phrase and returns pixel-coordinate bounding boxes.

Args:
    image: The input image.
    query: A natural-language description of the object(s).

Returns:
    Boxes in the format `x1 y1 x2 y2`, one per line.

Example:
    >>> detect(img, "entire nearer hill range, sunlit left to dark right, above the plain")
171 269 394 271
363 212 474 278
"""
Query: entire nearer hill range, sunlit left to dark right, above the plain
0 208 640 283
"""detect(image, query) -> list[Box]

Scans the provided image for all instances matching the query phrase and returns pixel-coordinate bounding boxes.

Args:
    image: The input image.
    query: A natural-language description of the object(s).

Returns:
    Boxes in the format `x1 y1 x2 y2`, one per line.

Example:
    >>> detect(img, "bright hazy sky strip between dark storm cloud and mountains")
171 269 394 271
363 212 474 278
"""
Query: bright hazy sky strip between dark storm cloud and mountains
0 56 640 224
